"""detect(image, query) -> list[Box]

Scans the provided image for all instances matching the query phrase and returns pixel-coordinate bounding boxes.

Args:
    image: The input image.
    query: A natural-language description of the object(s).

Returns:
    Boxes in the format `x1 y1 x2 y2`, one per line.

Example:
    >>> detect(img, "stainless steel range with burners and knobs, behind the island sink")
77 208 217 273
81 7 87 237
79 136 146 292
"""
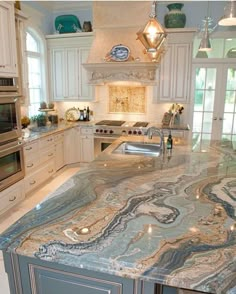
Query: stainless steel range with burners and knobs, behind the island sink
94 120 148 157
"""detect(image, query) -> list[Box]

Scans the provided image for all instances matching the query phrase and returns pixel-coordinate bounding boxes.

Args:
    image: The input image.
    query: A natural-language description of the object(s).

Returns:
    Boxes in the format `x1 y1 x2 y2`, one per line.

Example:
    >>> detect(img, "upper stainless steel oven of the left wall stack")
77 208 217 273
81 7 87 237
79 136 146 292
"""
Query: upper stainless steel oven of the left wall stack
0 94 21 145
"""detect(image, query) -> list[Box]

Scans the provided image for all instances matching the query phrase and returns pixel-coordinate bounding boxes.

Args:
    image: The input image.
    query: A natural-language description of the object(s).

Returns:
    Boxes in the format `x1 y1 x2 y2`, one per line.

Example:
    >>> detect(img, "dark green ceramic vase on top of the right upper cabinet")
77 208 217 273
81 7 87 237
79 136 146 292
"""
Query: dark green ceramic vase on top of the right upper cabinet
164 3 186 28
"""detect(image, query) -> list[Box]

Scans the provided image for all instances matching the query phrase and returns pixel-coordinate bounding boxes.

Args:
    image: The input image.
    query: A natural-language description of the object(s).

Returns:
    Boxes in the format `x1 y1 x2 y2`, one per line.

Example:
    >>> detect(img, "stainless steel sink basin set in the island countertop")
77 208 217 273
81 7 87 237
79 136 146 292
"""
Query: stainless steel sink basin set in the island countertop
112 142 162 157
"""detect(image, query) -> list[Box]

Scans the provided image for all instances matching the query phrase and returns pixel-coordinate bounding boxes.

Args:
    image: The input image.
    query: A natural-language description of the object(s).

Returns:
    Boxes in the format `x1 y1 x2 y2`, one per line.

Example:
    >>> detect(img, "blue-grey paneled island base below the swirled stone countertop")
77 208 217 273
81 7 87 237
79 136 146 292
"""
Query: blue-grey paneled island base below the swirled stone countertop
3 252 181 294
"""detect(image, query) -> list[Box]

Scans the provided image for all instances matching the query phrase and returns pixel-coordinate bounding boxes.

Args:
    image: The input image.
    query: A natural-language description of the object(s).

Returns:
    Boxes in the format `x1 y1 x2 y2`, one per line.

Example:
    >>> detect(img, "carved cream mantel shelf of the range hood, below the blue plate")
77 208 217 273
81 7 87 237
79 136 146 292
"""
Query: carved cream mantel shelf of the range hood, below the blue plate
83 62 158 85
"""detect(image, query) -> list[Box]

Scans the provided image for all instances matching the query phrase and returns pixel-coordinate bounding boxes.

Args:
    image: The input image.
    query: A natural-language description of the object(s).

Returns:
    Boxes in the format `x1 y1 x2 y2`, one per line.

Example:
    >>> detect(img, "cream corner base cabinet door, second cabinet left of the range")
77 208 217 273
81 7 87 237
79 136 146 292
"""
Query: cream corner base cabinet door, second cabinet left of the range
64 127 80 164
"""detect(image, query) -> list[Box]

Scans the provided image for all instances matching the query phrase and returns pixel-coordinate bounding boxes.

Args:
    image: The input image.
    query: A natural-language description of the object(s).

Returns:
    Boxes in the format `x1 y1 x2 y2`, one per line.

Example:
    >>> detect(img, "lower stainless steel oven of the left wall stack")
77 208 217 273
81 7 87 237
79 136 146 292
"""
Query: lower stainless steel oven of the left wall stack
0 140 25 191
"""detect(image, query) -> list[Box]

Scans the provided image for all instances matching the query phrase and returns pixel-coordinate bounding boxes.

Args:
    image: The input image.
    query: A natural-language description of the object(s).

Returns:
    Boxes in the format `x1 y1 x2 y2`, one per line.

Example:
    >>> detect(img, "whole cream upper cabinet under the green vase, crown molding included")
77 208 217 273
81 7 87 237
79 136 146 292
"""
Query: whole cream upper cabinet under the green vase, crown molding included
158 29 194 103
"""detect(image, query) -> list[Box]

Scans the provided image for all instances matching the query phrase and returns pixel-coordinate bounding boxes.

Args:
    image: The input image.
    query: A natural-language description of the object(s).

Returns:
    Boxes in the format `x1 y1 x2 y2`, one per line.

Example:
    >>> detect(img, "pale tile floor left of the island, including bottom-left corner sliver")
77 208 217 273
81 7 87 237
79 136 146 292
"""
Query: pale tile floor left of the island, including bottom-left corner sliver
0 166 79 294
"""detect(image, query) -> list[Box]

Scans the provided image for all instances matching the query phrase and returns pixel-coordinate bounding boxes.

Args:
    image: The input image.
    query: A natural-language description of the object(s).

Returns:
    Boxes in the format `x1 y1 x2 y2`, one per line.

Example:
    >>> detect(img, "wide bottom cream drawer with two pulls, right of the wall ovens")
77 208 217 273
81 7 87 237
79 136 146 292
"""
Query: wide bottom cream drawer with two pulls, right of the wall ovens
24 160 55 193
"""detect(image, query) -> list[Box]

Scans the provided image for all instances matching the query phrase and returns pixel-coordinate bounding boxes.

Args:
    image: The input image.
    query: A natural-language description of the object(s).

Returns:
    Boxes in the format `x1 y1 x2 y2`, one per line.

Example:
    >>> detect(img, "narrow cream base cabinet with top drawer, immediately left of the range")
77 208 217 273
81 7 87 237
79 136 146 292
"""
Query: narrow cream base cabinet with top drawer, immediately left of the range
80 127 94 162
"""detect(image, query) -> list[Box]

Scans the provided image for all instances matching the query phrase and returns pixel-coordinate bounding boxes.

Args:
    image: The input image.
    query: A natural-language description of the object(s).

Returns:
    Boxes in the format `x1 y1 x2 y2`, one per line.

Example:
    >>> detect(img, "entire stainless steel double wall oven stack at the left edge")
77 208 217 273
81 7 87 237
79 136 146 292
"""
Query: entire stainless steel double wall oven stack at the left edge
0 78 24 191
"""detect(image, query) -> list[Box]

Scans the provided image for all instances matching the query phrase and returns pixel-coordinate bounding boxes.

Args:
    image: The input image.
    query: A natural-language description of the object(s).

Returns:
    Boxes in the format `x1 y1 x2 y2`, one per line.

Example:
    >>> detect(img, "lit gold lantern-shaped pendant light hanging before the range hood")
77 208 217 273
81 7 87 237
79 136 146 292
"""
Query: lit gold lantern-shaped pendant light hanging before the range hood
137 1 167 55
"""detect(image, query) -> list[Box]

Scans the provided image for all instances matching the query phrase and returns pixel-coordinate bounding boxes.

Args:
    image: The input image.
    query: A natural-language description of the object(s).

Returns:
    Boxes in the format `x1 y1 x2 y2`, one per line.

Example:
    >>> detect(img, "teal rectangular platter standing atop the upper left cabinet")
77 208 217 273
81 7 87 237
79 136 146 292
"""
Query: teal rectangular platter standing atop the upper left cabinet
55 14 82 34
